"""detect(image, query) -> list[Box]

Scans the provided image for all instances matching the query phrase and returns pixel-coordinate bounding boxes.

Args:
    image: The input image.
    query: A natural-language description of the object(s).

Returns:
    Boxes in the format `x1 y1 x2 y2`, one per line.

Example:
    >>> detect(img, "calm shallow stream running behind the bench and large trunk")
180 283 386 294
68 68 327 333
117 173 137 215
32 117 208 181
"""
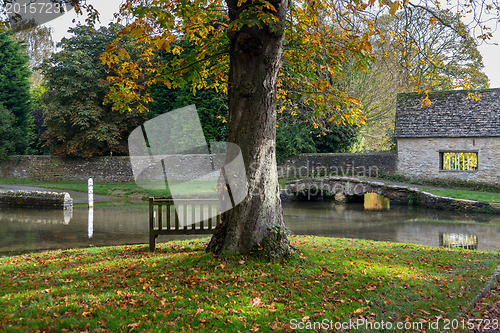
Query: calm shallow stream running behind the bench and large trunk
0 201 500 255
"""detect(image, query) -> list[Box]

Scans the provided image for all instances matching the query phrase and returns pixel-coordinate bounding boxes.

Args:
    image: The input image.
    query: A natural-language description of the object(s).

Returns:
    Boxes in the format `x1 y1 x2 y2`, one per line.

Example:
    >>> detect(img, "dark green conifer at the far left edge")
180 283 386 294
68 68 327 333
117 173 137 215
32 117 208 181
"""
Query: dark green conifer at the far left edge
0 26 31 154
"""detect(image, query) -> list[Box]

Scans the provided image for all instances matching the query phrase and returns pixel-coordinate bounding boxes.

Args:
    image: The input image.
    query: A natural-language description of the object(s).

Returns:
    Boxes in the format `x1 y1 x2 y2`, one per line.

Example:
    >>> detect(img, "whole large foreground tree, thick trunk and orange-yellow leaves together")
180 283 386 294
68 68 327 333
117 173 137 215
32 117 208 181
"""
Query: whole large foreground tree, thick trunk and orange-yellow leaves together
95 0 499 259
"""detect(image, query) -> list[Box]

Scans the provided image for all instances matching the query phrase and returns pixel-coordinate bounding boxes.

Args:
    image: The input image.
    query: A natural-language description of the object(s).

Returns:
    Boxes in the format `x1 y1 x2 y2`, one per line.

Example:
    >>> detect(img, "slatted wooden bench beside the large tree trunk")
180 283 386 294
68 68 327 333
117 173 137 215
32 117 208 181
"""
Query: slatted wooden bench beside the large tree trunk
149 197 221 252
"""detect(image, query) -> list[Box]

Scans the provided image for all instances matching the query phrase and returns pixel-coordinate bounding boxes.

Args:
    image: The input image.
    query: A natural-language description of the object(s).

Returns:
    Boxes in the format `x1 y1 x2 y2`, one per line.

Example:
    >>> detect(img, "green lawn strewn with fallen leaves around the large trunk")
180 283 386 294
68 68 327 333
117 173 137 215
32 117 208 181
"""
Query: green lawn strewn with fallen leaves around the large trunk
0 236 500 332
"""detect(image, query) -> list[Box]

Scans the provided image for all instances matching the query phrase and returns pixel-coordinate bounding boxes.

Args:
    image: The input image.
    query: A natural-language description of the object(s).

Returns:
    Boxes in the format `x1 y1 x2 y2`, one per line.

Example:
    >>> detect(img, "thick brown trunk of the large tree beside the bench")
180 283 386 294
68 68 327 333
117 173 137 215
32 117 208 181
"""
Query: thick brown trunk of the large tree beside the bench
207 0 293 261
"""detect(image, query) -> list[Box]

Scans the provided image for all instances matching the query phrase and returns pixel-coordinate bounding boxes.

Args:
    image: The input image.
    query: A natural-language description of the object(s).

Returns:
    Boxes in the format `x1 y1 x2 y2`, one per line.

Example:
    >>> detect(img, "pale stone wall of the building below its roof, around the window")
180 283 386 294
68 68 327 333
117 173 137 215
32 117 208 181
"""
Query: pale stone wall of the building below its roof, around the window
397 137 500 187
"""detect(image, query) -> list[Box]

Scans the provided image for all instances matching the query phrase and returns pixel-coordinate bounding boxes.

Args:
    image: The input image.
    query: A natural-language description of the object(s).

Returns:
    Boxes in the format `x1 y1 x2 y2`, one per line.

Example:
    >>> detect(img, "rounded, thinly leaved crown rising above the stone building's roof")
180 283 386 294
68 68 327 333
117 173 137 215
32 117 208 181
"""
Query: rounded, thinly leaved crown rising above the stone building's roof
378 7 488 93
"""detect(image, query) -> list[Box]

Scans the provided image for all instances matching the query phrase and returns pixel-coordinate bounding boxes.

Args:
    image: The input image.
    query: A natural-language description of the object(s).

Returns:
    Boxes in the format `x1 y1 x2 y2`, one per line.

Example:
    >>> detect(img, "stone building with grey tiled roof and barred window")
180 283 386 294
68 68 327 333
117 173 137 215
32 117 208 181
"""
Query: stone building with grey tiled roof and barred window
395 89 500 187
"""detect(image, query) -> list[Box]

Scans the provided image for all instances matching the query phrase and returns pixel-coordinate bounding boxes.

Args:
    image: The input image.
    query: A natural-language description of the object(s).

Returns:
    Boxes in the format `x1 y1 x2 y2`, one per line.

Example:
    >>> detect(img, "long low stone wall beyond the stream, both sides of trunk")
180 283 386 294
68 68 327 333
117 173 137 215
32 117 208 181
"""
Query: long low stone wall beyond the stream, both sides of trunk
0 153 396 182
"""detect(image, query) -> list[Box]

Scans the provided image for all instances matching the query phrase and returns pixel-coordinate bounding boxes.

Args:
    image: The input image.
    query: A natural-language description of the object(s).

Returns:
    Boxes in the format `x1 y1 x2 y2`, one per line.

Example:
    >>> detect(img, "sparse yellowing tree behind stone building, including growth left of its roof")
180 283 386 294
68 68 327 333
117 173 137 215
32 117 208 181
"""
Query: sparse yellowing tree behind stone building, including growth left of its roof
345 8 488 150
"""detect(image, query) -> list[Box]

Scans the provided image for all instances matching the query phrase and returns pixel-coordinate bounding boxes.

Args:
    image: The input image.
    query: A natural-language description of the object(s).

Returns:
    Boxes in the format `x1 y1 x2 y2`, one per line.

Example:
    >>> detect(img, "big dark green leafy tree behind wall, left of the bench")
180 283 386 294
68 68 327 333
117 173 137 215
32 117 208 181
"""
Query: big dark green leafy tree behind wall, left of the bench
41 24 145 158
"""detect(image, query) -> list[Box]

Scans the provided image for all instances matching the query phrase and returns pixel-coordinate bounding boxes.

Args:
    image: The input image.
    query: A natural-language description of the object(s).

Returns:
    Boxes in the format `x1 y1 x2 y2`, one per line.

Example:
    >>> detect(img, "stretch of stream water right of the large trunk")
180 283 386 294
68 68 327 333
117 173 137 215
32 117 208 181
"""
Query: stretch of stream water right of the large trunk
284 201 500 251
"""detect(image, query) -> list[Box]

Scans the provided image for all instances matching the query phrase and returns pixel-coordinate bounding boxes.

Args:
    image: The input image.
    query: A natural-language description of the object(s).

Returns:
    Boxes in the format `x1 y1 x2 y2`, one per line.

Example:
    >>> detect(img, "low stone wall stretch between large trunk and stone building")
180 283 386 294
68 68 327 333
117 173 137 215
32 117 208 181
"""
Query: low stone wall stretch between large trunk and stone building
278 153 397 178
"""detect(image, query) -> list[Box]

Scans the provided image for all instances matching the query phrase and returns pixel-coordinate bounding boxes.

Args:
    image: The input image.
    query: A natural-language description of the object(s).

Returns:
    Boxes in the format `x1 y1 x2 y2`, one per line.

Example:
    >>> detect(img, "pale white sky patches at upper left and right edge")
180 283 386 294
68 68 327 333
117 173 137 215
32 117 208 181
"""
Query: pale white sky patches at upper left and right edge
46 0 500 88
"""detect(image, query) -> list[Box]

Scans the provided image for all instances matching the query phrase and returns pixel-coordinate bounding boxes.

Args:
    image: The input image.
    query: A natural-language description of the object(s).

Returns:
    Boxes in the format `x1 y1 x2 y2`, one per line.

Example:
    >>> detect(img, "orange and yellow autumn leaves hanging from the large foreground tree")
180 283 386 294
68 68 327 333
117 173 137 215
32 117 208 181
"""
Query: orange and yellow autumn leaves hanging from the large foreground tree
101 0 499 125
